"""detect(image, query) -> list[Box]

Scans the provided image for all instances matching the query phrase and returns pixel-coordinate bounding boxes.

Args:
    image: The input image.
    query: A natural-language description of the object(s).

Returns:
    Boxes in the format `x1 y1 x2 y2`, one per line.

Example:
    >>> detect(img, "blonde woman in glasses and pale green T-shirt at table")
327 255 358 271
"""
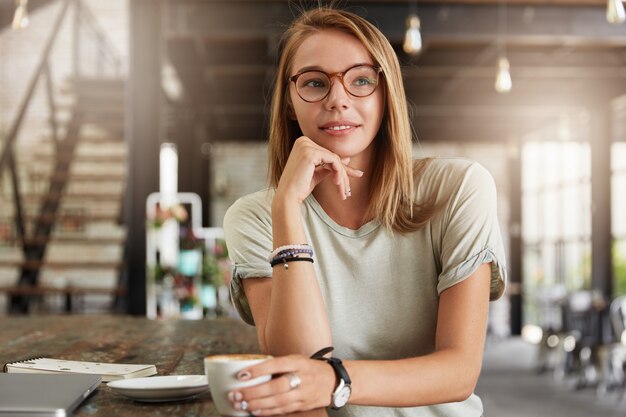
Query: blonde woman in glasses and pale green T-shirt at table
224 8 505 417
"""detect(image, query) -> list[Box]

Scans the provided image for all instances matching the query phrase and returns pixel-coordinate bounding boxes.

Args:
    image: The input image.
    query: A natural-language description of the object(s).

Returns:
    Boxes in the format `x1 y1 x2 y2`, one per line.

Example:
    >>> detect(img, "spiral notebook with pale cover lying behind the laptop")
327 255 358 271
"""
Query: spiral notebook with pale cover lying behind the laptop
4 358 157 382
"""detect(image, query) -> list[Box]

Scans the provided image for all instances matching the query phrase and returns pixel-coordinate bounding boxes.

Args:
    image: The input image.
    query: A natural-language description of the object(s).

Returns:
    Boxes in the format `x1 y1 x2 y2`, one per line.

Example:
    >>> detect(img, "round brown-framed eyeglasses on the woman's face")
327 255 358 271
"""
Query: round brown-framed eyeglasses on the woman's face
289 65 382 103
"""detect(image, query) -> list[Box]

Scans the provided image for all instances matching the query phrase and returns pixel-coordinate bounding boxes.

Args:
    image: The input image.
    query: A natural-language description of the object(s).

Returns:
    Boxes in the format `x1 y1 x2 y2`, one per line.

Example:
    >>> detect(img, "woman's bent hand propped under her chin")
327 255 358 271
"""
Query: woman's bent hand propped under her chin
276 136 363 203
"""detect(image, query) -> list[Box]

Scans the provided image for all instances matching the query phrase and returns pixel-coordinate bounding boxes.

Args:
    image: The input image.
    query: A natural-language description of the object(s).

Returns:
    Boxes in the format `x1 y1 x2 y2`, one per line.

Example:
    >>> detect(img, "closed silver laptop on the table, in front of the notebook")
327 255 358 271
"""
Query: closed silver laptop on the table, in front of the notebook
0 373 101 417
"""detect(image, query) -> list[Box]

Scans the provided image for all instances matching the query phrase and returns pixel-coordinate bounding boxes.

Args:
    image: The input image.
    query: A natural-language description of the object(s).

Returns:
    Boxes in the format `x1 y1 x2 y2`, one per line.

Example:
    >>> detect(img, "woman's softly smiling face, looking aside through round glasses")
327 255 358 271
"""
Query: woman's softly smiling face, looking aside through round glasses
289 30 384 166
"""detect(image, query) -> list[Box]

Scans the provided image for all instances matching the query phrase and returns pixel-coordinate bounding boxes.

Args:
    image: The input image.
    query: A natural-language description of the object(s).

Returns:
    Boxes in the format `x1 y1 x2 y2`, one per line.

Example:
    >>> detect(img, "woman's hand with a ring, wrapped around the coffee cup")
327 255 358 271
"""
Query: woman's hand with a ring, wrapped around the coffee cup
228 355 335 416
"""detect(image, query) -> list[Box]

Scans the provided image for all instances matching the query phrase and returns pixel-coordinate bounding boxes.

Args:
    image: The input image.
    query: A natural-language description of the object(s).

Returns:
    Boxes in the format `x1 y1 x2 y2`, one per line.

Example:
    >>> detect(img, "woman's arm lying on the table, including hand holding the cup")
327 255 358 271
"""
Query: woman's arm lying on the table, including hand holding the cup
234 264 491 415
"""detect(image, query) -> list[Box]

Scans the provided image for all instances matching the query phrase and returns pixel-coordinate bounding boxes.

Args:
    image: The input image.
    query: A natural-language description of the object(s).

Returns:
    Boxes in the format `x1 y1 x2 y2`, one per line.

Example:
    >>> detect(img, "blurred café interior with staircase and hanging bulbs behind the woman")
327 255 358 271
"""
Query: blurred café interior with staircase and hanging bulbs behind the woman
0 0 626 416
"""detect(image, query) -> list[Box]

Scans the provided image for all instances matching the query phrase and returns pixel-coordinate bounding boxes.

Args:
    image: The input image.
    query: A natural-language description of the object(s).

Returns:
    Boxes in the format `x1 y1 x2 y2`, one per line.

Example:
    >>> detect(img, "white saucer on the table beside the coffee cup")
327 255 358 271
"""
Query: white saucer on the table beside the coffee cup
107 375 209 402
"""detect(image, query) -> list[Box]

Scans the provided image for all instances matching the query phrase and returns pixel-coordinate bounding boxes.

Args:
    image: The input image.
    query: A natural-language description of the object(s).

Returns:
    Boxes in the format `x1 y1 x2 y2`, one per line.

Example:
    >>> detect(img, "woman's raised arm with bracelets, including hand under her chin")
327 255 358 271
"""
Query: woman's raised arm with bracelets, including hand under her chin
244 137 363 356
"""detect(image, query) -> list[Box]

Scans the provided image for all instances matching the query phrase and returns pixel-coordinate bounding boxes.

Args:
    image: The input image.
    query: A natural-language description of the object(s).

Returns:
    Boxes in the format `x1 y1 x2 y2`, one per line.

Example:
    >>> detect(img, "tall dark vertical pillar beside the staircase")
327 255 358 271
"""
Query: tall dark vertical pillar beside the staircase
123 0 161 315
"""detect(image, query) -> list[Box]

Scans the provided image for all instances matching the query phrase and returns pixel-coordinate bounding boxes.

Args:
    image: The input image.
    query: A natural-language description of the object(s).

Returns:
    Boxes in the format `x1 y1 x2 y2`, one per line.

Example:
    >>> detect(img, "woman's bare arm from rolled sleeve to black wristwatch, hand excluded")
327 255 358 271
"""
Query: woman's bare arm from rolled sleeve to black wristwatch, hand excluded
344 264 491 407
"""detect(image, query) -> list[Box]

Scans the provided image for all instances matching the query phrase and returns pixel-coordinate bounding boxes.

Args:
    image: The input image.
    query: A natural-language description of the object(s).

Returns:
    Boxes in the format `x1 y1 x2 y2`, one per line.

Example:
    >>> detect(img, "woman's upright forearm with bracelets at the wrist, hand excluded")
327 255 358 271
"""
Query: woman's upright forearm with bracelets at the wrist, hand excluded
265 198 332 355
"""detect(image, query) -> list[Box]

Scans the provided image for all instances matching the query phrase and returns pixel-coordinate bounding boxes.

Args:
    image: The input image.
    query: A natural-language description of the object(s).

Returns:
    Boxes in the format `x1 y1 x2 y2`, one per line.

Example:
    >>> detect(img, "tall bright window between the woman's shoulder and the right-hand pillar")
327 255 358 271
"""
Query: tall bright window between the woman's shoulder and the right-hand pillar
522 141 588 323
